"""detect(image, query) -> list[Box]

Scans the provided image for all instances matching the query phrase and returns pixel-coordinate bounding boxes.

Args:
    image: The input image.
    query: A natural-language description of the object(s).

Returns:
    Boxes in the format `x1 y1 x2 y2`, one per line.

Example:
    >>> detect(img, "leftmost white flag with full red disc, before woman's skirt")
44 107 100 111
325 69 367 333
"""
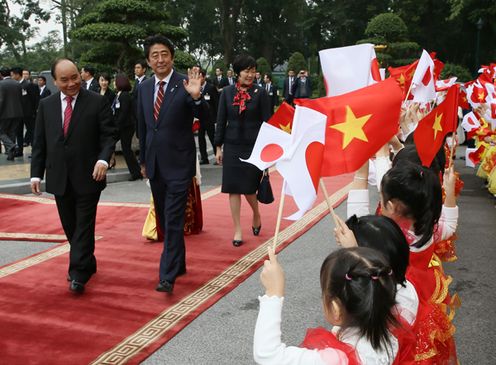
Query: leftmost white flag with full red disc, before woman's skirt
240 123 291 170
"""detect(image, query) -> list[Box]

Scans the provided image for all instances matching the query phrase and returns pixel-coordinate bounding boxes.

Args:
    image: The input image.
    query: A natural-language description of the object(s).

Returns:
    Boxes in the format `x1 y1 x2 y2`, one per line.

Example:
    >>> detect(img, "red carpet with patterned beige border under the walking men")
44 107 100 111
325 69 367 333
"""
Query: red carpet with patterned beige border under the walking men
0 173 351 365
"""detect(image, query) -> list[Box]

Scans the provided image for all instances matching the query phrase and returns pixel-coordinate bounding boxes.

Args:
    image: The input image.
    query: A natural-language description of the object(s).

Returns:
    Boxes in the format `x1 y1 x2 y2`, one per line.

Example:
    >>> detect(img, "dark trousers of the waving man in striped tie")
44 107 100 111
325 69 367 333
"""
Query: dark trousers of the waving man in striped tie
150 175 191 283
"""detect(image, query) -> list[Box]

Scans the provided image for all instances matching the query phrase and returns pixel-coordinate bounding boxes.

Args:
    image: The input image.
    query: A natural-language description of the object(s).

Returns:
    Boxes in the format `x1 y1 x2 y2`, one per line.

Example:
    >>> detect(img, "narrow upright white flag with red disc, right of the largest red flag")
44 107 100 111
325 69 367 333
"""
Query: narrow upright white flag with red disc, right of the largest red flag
411 49 436 103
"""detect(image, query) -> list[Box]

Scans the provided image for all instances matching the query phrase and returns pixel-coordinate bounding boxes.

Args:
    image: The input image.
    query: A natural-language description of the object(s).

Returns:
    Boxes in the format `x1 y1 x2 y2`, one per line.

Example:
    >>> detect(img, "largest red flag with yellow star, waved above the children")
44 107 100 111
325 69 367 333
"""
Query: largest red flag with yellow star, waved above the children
295 78 403 176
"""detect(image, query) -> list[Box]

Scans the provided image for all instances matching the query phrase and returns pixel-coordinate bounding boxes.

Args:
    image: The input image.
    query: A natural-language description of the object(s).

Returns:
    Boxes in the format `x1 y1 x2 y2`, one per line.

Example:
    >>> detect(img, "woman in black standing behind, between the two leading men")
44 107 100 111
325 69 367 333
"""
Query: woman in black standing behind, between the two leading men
112 74 142 181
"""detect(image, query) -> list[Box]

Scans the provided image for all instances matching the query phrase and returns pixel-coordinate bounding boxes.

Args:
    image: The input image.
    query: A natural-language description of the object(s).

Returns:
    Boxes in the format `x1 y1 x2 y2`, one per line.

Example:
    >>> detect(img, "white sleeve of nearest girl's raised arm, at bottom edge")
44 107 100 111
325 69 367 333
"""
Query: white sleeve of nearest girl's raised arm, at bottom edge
253 295 348 365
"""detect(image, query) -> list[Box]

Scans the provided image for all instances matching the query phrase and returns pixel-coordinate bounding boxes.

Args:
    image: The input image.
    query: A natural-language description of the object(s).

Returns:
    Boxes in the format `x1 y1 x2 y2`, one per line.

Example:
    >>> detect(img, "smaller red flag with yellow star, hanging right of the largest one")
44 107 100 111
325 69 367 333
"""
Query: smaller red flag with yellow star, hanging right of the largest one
413 85 458 167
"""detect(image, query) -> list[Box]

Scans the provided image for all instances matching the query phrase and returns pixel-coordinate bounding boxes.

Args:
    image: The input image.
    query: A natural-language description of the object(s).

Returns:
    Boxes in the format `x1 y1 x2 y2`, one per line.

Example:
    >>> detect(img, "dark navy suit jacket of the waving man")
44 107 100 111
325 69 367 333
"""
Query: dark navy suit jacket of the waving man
138 70 205 181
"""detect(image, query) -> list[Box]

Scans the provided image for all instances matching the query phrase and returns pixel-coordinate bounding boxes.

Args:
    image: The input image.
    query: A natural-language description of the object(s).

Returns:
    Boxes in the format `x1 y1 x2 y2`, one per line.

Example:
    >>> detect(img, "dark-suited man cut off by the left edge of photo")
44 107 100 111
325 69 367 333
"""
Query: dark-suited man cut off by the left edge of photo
0 68 23 161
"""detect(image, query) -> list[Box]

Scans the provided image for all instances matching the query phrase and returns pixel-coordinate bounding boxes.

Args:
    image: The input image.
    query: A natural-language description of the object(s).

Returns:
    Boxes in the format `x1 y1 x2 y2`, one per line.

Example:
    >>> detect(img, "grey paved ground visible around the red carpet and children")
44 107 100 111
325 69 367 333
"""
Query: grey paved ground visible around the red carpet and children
0 150 496 365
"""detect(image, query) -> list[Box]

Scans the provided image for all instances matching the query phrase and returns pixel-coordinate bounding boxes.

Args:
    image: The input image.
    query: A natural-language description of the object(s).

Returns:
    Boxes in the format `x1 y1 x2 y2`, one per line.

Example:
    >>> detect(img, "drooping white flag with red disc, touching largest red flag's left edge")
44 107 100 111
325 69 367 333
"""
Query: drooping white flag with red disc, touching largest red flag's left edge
276 106 327 220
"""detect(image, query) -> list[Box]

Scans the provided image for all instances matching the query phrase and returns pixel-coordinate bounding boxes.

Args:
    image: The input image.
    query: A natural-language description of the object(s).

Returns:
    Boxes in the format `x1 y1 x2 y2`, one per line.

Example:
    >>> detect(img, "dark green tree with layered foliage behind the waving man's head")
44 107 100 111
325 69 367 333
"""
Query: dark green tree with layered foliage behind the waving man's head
70 0 190 72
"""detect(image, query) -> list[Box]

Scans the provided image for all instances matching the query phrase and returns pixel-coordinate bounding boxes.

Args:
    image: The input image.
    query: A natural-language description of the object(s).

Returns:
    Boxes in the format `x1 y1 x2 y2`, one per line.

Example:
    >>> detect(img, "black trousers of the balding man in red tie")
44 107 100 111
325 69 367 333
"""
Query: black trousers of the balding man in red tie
55 182 100 283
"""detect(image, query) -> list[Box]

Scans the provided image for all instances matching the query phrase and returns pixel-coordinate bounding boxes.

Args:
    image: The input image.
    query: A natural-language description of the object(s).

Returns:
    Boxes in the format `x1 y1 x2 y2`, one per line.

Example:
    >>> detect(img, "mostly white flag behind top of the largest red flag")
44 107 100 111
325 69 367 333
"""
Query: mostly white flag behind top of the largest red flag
319 43 381 96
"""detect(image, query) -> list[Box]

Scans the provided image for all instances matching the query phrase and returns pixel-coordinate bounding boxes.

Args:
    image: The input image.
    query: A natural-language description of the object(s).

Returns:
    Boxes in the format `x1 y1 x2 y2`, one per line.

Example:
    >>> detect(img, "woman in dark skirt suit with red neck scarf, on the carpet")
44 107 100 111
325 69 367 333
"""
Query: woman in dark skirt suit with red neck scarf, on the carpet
215 55 270 247
